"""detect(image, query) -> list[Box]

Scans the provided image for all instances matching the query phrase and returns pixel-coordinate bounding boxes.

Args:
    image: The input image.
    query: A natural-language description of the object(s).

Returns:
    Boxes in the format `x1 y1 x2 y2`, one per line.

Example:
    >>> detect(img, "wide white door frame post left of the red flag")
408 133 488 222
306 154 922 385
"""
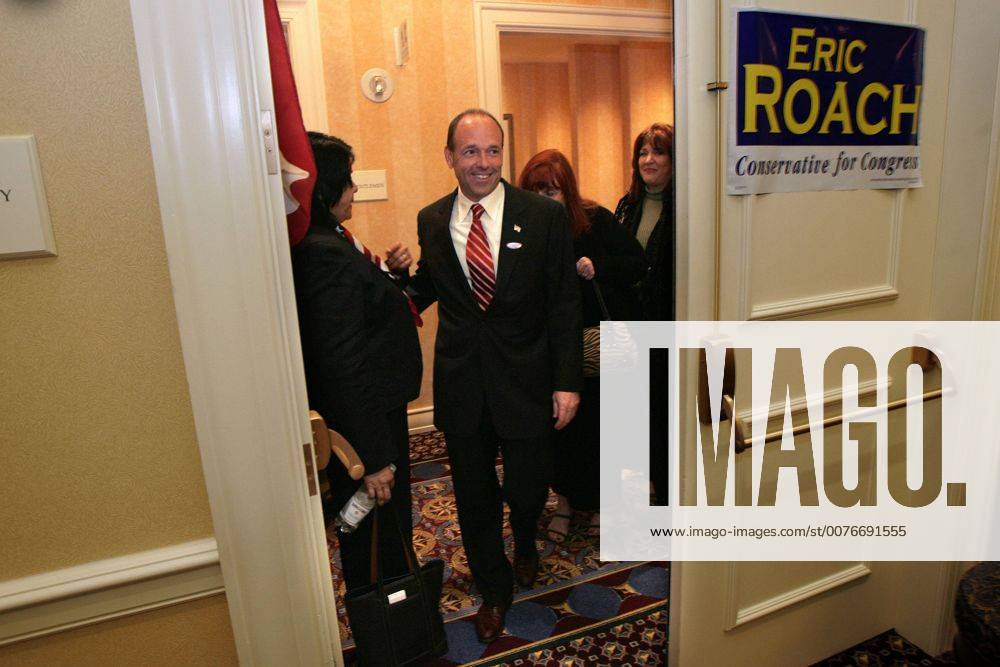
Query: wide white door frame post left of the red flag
131 0 342 666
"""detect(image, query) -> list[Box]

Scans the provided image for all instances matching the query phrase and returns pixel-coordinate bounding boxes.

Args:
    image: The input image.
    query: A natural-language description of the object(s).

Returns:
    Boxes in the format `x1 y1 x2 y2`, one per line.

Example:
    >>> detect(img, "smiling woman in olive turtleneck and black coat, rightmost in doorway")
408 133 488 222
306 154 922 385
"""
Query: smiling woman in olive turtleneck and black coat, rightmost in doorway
615 123 674 320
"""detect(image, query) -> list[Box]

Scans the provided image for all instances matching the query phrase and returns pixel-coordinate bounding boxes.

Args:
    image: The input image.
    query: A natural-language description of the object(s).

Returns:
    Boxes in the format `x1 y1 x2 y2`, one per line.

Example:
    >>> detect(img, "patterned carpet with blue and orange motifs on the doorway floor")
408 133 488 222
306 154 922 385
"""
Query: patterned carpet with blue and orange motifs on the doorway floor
328 432 669 667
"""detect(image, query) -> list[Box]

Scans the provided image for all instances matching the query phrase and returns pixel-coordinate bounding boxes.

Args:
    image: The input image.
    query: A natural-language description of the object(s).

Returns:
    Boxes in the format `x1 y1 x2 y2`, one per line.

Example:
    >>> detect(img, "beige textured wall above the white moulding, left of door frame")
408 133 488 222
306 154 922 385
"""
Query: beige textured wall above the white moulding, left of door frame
0 0 212 580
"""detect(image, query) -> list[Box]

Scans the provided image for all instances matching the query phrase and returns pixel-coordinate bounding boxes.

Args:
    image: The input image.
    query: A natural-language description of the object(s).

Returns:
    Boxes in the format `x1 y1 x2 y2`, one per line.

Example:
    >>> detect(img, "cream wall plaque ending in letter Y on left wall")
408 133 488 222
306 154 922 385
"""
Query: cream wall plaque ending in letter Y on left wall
0 135 56 259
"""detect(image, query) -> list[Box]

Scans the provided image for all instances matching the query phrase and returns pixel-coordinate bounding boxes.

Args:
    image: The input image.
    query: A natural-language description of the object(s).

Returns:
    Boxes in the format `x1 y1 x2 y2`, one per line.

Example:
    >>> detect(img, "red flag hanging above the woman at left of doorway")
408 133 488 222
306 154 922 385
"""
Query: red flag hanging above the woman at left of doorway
264 0 316 245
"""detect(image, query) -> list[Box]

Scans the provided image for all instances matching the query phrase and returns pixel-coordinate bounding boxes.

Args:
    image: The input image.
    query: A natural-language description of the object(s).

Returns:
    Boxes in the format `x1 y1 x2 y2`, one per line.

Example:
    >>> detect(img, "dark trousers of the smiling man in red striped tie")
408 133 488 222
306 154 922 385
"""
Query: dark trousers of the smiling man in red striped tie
445 411 551 605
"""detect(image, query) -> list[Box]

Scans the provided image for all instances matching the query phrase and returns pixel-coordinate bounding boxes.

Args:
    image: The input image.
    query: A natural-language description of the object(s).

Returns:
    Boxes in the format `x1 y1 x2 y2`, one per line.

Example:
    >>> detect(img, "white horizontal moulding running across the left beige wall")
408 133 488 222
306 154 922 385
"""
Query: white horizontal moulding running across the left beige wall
0 538 225 646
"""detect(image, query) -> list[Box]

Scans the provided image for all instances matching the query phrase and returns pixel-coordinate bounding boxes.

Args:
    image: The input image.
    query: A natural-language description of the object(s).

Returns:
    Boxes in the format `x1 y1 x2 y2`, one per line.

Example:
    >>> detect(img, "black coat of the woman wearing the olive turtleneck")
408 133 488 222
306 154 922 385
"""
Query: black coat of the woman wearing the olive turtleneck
615 184 676 320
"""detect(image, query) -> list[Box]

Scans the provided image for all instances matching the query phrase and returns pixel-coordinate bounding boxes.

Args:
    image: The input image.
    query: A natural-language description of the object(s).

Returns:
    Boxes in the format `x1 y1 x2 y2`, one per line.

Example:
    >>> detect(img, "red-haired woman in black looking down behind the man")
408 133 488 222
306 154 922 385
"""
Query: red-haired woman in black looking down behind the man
519 149 646 543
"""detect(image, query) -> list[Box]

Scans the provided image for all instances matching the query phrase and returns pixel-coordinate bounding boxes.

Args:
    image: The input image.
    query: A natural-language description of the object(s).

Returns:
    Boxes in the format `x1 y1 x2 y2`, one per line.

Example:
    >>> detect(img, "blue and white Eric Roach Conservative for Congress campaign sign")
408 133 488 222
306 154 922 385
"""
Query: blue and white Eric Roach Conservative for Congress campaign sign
726 8 925 195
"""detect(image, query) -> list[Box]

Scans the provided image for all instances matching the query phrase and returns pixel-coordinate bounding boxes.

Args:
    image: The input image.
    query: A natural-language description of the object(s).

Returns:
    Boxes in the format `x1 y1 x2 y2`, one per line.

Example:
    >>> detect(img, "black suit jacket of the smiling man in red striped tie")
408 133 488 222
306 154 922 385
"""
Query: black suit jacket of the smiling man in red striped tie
408 183 583 438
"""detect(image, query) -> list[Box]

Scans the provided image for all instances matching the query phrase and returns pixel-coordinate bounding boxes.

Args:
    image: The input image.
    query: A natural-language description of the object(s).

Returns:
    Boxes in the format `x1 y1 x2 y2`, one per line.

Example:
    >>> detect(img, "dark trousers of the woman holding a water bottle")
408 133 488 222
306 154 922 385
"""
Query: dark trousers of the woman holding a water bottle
327 405 413 591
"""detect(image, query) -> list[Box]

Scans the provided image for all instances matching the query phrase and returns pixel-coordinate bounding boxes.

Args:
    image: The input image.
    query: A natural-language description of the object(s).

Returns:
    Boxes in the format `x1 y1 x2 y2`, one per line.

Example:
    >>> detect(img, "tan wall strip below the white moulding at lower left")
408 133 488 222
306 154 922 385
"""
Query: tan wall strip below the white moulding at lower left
0 595 238 667
